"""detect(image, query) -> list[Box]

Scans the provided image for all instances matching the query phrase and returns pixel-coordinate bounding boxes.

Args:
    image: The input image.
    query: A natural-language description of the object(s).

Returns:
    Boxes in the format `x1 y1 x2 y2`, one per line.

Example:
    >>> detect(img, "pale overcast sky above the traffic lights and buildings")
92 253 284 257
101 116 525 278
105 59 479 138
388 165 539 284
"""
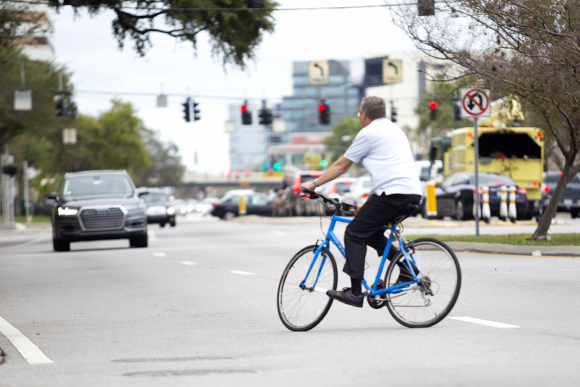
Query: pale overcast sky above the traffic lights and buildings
46 0 414 175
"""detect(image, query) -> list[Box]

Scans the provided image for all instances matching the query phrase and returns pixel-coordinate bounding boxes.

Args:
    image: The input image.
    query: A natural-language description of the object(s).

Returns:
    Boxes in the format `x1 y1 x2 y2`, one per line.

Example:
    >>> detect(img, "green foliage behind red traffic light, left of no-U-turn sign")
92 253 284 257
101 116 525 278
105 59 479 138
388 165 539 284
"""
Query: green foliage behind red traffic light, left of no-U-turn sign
415 81 473 136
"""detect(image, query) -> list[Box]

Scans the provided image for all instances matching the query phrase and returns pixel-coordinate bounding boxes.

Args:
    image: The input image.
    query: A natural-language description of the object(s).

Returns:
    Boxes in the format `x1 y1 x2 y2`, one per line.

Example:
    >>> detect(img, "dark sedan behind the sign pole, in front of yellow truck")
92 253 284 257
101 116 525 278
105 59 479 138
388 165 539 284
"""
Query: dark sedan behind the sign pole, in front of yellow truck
435 172 528 220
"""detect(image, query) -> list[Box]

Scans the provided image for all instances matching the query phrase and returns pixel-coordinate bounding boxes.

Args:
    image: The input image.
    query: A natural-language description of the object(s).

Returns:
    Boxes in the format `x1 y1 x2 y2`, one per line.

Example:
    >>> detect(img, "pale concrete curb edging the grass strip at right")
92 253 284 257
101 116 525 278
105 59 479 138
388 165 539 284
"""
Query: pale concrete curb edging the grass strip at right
444 242 580 257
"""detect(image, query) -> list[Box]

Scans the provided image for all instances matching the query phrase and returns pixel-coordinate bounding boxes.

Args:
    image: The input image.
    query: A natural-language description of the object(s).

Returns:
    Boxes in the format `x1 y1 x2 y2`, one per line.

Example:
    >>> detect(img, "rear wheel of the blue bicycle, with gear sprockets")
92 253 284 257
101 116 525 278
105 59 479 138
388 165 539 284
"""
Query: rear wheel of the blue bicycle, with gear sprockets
385 238 461 328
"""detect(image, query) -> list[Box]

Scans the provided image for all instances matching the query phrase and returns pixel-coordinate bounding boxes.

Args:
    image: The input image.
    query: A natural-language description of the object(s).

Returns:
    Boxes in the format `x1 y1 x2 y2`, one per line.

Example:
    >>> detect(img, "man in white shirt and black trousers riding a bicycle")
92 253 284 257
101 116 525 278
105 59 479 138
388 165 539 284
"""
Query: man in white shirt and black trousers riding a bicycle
301 96 421 308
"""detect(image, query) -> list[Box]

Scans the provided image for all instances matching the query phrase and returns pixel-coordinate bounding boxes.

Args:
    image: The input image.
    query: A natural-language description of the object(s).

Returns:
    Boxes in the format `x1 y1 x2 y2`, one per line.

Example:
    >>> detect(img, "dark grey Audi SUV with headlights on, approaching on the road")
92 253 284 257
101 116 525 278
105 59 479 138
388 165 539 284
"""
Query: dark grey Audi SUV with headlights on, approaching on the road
48 170 147 251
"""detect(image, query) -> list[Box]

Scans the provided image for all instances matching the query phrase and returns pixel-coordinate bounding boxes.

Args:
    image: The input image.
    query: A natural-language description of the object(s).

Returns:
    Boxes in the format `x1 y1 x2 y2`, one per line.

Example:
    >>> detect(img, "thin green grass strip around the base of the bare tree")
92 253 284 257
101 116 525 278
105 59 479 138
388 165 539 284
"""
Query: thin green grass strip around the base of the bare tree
404 234 580 246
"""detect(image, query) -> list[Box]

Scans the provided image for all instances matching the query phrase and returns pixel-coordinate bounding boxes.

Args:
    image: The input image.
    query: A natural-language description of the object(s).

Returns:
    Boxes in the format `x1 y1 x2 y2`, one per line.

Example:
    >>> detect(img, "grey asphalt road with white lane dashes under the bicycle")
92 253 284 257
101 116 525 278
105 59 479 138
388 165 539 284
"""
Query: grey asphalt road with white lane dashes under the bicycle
0 217 580 386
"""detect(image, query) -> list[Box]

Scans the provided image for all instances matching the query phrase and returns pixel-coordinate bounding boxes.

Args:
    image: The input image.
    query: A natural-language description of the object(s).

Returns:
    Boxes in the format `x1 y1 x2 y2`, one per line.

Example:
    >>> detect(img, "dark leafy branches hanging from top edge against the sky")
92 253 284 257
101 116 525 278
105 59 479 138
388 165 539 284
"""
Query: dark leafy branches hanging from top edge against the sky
49 0 278 68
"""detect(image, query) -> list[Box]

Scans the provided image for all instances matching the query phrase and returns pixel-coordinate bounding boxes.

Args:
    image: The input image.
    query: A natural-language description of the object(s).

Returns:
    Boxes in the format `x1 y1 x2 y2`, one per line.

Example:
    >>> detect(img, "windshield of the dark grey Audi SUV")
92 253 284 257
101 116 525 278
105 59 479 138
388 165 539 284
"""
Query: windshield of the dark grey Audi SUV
62 175 133 200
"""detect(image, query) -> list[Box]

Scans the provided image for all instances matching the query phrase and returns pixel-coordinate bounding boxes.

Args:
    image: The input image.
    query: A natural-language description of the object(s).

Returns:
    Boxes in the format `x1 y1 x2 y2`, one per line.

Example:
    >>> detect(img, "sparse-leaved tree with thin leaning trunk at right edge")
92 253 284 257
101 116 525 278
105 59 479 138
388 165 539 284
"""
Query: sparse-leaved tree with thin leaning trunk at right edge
395 0 580 239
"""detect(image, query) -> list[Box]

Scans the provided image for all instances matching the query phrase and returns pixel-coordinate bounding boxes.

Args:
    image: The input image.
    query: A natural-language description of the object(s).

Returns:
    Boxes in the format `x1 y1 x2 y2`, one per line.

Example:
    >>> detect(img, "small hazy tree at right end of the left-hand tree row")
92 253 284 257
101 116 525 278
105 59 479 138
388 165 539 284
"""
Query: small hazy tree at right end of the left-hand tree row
134 127 185 186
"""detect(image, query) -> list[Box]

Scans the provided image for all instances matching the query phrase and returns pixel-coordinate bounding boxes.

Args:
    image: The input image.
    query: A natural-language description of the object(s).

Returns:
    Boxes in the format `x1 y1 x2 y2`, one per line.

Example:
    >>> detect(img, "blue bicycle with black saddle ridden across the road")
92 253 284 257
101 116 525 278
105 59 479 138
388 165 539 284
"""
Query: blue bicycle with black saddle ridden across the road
277 192 461 331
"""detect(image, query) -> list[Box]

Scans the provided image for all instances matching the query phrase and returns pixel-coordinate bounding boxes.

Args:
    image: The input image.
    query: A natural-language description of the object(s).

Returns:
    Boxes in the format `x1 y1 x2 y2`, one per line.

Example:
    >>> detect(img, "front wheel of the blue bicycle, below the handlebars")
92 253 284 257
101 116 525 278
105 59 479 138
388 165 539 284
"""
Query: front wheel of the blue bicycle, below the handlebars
277 245 338 331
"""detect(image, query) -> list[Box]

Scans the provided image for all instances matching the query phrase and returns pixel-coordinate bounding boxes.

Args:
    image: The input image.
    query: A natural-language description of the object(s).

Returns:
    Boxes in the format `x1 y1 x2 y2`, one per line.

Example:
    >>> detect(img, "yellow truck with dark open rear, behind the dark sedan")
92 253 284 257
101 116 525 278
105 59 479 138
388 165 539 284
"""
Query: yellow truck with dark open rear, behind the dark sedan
431 127 544 219
